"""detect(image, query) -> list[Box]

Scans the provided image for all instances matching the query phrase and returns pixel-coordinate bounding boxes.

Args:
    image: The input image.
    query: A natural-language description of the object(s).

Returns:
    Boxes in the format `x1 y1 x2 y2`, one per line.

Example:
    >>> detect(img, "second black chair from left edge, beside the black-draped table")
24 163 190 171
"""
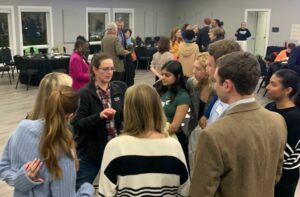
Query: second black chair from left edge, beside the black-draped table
14 55 38 90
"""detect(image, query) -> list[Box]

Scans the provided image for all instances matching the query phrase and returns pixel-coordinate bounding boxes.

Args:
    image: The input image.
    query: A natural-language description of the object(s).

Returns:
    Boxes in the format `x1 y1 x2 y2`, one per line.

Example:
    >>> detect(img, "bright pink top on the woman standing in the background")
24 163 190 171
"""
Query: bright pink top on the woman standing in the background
69 51 90 90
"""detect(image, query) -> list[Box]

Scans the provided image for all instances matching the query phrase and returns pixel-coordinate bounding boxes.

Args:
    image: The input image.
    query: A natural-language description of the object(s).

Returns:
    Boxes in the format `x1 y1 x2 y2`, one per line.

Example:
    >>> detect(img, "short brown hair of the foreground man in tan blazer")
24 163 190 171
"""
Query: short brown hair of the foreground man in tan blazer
217 51 260 96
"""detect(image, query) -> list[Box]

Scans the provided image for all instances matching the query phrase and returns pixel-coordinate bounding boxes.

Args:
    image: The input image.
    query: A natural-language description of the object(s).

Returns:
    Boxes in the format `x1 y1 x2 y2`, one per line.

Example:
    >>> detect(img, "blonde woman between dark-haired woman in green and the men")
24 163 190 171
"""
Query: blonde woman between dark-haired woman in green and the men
186 52 215 172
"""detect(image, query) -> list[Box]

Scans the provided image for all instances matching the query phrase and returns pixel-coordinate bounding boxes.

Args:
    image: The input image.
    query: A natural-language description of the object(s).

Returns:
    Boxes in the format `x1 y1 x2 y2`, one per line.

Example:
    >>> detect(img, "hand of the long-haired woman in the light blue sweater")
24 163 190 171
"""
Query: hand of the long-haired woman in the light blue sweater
24 159 44 183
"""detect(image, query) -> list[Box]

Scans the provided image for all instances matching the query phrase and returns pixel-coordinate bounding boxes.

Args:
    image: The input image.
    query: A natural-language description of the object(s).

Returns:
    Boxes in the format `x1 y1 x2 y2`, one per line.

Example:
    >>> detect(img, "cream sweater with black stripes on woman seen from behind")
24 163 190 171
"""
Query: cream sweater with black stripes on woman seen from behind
99 135 190 197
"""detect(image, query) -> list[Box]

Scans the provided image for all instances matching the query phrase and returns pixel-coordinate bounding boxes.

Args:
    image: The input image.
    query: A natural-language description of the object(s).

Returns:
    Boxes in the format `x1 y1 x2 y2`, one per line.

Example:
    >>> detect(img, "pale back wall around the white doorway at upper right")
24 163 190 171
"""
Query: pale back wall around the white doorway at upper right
175 0 300 45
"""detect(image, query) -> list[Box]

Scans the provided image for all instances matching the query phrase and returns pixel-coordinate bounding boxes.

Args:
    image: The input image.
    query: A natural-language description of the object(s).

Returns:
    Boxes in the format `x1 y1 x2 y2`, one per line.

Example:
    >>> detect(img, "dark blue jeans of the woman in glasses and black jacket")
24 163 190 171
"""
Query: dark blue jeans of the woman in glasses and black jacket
76 155 101 191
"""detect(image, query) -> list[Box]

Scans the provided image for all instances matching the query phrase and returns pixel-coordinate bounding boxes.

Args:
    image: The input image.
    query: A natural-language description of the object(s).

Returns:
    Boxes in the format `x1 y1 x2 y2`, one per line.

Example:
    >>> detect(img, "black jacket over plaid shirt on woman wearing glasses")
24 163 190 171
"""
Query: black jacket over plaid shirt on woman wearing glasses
72 81 127 161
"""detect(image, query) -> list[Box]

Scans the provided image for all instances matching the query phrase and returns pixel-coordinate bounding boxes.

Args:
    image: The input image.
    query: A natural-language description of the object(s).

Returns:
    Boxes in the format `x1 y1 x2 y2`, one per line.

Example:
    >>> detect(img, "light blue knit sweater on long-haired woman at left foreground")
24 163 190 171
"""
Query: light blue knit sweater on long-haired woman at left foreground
0 120 94 197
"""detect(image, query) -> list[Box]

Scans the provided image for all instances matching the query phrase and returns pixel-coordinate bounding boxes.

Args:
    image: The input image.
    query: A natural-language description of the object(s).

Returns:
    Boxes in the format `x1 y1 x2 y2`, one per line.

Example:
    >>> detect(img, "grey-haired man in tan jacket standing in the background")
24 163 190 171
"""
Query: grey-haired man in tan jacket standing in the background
101 23 129 81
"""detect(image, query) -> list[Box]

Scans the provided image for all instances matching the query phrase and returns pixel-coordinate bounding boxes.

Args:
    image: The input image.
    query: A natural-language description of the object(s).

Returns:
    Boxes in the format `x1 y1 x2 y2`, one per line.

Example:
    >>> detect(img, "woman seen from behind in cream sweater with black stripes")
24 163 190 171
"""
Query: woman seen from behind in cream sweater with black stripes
99 84 190 196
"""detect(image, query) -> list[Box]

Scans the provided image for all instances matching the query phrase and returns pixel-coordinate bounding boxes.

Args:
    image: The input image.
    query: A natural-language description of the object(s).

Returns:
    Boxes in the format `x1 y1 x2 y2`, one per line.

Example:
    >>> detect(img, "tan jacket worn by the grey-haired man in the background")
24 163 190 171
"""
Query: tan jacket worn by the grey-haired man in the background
101 34 129 72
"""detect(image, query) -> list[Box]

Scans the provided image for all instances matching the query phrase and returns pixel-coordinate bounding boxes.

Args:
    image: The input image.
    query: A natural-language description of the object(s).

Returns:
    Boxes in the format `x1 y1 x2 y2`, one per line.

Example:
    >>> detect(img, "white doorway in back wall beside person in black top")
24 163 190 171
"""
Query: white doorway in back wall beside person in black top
245 9 271 57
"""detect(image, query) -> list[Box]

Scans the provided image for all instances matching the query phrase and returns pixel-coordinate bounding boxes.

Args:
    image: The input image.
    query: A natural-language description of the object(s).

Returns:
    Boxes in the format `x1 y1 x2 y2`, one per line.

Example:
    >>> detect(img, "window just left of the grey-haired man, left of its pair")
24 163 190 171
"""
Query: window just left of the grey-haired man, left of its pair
86 8 110 44
